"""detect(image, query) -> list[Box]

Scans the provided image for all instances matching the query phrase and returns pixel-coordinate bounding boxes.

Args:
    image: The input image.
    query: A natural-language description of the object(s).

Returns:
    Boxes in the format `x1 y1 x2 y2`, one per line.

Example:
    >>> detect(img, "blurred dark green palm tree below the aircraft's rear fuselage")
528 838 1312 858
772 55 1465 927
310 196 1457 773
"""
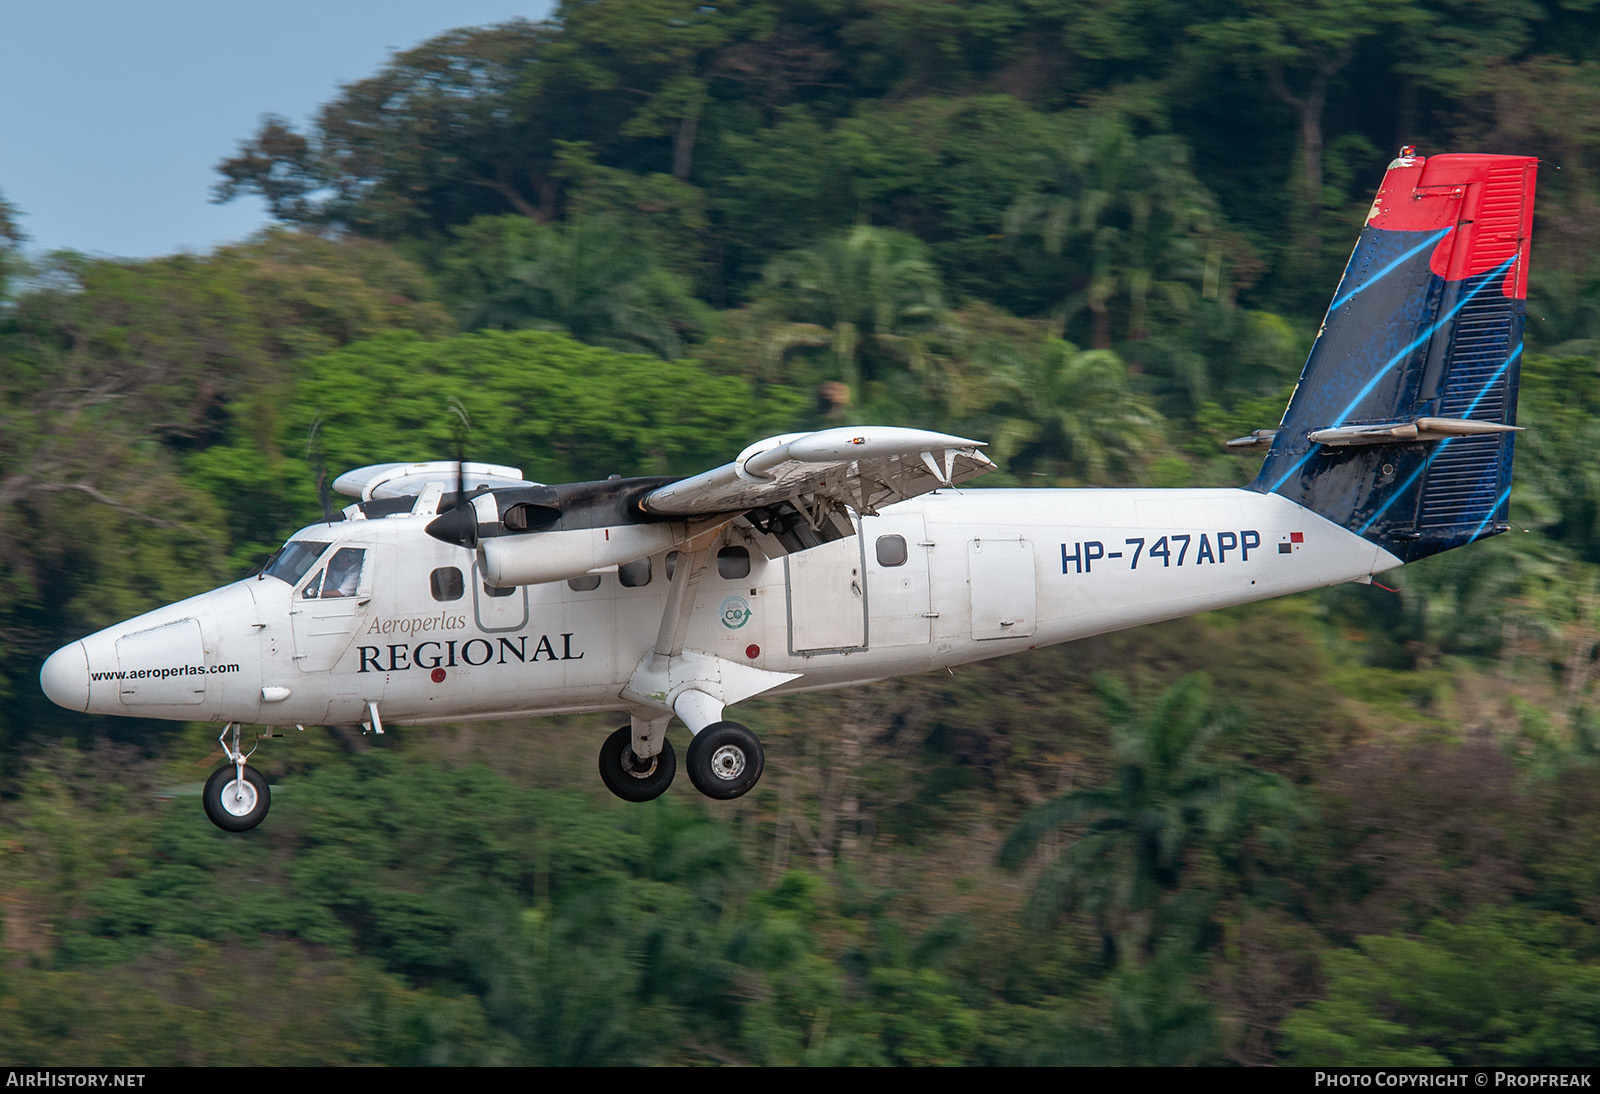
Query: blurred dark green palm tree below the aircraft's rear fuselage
1000 673 1298 961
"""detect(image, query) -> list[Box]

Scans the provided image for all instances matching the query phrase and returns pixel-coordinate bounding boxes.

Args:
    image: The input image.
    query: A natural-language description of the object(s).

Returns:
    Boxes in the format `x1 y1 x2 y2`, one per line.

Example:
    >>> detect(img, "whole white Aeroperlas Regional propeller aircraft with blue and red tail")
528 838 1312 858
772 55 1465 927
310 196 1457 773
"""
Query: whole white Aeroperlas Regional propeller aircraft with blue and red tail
40 149 1536 832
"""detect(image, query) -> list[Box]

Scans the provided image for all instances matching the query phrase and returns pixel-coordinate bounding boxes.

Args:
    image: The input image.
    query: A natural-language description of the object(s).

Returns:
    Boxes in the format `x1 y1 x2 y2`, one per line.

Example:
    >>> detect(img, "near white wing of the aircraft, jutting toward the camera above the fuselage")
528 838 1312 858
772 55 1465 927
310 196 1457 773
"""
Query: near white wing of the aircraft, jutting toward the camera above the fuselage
640 425 994 518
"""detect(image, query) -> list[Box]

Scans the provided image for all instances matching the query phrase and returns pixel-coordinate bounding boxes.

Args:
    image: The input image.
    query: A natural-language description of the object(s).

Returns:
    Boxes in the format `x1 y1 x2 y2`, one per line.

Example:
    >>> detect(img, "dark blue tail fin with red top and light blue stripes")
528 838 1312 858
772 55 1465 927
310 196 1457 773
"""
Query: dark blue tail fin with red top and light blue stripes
1251 149 1538 561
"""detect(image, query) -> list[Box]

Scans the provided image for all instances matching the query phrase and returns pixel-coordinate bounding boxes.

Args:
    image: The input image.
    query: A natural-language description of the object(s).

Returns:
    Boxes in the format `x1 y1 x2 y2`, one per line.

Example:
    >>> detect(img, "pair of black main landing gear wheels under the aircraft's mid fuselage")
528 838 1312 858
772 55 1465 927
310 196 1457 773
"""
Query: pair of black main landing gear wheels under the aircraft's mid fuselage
600 721 766 801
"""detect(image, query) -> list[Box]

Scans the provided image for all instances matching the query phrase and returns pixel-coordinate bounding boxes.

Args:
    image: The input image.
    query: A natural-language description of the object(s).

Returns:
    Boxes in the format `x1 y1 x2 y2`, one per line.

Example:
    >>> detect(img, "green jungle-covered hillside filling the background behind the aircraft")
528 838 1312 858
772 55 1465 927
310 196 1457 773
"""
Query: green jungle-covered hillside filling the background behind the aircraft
9 0 1600 1067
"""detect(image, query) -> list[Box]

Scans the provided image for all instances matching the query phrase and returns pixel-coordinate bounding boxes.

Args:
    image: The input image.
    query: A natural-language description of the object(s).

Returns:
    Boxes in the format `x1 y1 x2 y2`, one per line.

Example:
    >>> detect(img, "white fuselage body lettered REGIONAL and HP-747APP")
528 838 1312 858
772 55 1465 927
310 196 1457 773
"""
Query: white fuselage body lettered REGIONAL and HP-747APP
56 489 1400 726
